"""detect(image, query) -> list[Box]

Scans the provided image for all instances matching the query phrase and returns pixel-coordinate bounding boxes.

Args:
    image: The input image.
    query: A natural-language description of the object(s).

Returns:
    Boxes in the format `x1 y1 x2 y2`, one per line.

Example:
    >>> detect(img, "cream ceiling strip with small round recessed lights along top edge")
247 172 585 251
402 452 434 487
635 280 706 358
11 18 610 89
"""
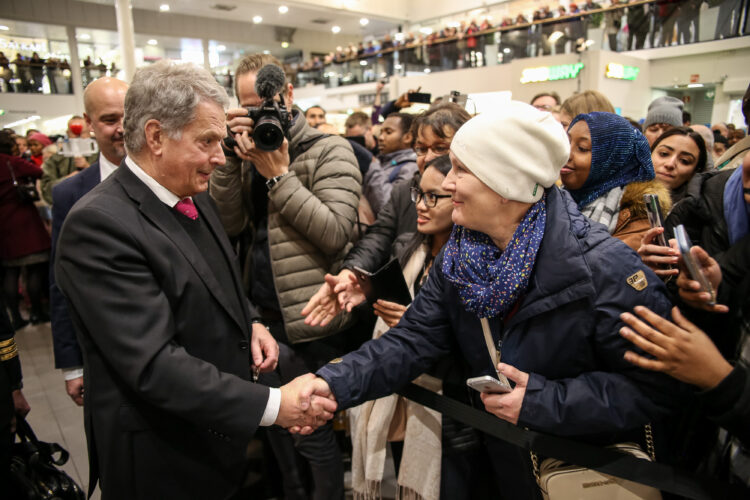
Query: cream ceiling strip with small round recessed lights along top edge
82 0 399 37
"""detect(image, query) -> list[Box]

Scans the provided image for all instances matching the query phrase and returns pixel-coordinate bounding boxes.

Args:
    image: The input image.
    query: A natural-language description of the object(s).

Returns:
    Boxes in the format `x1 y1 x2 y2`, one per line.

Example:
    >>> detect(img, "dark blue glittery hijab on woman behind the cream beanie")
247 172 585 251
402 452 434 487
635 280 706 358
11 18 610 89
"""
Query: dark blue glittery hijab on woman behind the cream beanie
568 111 654 208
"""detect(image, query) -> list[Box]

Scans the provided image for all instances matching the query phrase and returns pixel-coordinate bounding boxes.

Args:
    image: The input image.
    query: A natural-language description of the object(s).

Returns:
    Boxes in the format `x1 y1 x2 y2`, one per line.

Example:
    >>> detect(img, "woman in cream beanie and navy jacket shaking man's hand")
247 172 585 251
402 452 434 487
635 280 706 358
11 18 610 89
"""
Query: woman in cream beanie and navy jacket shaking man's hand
308 101 680 499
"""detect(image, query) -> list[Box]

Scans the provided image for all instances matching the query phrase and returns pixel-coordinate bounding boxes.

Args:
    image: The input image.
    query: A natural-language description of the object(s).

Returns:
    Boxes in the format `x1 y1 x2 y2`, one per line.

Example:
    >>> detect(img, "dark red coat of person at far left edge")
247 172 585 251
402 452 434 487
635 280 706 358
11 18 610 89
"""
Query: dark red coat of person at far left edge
0 154 50 260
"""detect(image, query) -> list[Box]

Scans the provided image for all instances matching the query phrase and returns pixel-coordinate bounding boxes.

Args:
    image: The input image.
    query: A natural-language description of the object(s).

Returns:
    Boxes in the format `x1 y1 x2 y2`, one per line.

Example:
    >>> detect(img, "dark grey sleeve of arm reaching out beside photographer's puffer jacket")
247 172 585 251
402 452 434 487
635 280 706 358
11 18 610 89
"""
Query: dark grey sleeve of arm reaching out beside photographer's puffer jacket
342 182 409 271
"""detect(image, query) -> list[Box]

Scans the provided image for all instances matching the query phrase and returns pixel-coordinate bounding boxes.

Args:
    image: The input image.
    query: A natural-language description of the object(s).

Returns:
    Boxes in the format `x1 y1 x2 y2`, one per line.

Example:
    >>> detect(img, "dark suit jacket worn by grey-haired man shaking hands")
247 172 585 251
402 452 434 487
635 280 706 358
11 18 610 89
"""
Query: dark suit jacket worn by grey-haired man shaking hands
55 165 269 499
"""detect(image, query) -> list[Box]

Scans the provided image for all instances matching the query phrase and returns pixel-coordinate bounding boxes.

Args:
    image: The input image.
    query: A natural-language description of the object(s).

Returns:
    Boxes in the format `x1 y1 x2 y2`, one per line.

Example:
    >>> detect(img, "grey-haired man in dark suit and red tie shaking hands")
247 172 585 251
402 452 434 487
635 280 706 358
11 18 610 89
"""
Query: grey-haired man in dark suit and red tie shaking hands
55 61 336 499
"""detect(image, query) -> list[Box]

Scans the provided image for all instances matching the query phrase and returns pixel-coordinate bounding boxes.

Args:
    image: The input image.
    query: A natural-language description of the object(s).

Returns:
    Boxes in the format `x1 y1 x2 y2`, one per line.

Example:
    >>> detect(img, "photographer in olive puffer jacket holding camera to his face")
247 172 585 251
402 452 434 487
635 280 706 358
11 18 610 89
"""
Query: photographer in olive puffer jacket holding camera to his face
210 54 362 499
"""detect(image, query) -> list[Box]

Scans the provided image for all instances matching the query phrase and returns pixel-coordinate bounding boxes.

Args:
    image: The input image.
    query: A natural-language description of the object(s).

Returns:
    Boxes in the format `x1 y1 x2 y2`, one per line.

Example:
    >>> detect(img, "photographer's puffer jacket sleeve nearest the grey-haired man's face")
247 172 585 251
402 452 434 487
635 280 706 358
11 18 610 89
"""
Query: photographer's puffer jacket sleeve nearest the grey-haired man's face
210 157 249 237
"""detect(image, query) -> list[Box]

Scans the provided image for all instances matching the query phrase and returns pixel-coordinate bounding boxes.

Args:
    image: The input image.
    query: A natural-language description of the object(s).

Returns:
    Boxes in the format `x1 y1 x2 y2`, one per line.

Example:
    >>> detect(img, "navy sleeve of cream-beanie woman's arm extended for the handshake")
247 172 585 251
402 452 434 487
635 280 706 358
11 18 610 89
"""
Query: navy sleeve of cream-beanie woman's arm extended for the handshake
317 256 453 408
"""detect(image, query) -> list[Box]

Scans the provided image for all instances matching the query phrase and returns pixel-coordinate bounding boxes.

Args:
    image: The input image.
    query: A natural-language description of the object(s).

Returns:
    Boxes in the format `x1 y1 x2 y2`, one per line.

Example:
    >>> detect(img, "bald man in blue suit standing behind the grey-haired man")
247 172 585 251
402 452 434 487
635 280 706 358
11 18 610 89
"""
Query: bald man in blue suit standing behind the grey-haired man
49 77 128 406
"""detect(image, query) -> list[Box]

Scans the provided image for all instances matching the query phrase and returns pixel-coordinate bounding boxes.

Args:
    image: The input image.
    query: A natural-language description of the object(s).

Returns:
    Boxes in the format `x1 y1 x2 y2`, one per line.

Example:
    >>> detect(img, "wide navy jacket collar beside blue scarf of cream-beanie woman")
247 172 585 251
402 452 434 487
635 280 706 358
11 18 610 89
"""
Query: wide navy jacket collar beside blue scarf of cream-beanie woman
507 186 609 326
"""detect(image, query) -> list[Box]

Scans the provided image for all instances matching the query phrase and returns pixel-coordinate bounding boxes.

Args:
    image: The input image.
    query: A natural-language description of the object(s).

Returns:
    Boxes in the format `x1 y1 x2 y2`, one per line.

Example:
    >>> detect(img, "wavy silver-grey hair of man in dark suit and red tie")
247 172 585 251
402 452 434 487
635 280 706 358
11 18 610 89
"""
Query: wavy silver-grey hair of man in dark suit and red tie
123 61 229 154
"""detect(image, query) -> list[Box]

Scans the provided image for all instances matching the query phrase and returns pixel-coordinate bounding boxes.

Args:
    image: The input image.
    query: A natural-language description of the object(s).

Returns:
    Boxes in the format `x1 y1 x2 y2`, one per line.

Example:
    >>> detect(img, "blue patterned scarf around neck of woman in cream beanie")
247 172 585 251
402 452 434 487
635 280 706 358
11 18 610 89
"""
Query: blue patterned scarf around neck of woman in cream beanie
443 193 547 318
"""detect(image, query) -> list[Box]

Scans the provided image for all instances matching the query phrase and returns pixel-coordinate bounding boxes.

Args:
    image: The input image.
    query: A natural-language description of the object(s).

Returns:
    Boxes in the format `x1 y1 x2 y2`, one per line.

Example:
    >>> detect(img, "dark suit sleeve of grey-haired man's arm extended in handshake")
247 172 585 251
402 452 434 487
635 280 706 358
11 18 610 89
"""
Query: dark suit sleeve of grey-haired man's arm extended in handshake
55 206 268 439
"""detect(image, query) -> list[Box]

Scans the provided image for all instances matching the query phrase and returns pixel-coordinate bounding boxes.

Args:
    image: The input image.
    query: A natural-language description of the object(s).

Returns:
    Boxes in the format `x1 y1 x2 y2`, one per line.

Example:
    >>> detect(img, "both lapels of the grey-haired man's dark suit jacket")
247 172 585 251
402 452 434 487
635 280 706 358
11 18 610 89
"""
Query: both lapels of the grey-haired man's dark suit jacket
112 160 249 336
